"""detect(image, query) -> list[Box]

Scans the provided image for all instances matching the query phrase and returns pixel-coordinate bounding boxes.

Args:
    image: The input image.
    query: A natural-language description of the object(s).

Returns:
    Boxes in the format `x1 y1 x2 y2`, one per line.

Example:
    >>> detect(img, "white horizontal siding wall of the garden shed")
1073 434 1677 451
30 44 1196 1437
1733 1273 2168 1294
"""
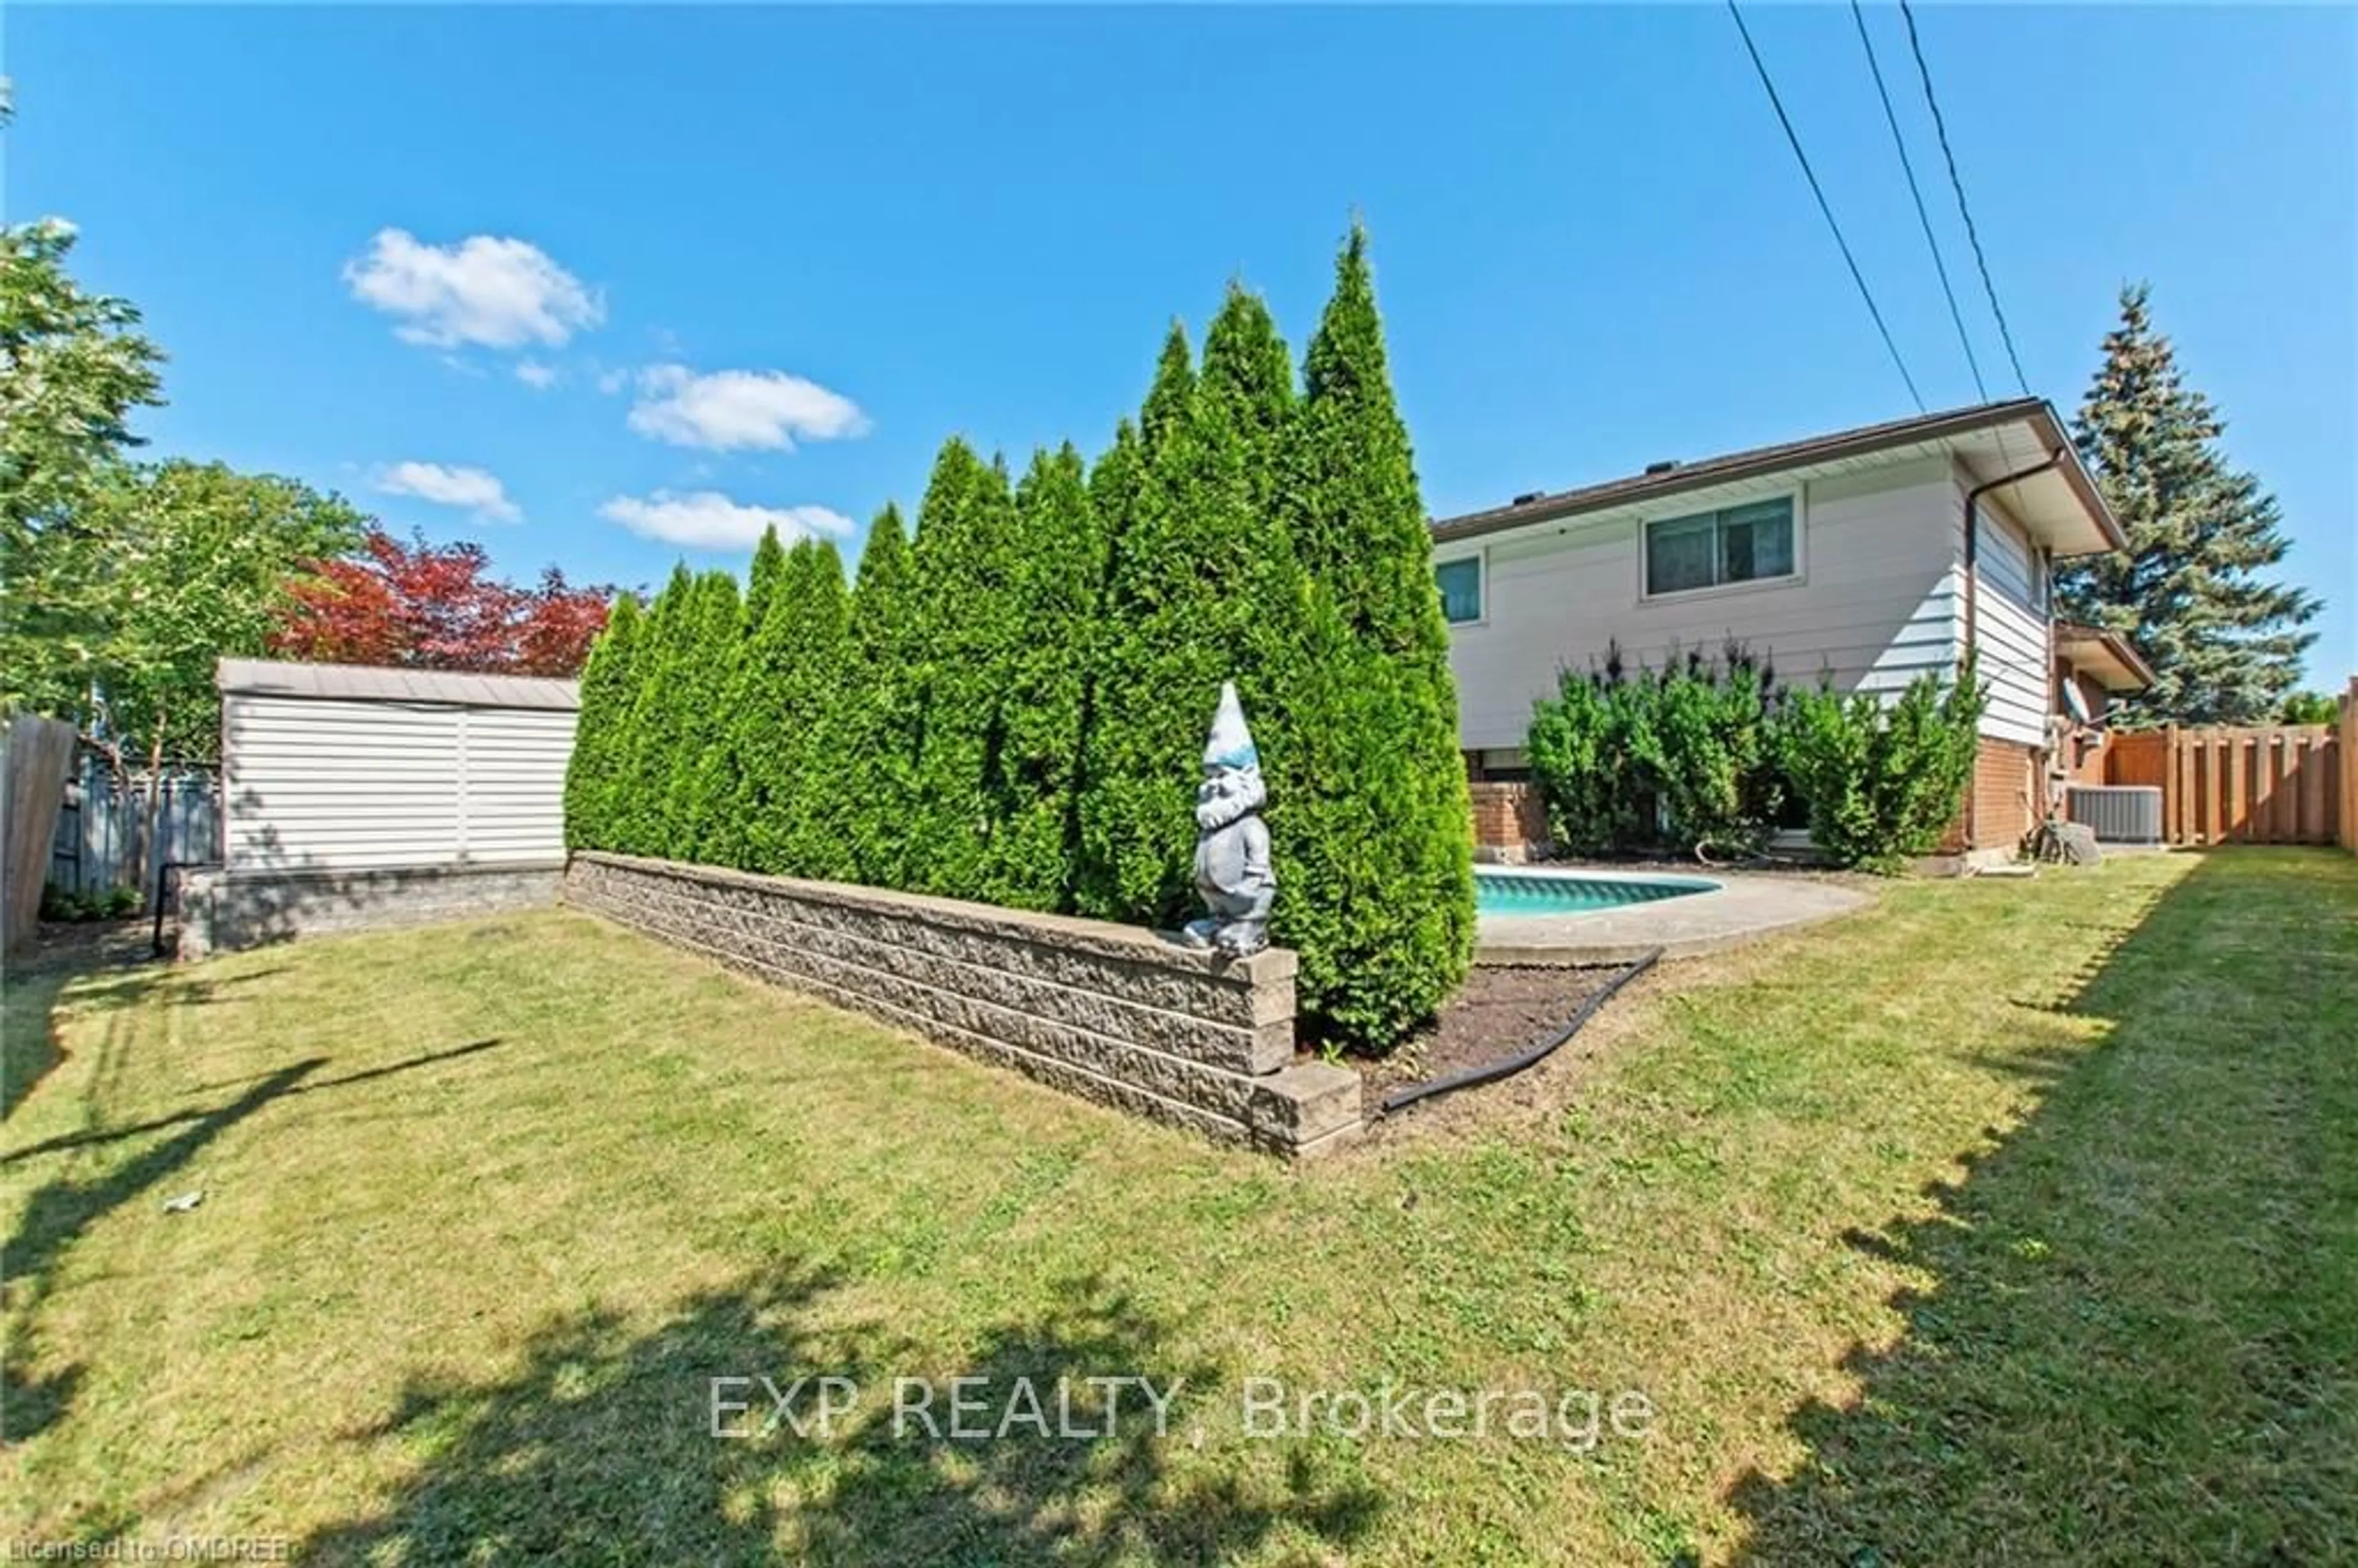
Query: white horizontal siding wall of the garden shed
222 693 575 870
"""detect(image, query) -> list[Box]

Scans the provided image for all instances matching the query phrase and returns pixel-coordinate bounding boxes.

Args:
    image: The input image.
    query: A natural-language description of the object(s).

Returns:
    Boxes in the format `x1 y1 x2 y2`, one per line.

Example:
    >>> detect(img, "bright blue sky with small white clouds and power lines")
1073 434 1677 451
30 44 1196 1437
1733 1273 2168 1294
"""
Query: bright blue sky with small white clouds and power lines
0 5 2358 686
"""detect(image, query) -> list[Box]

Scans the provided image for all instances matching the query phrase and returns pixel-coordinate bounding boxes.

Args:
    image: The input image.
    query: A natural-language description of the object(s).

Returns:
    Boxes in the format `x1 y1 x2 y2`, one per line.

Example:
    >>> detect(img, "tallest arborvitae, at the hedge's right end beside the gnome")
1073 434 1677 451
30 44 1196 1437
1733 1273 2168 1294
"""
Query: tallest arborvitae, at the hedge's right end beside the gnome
1271 227 1474 1049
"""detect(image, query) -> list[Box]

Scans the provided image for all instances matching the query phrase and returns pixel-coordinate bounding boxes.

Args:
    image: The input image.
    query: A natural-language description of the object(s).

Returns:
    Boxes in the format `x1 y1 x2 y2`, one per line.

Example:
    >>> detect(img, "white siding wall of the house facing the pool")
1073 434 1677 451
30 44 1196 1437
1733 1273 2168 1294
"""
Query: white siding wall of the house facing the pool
1436 457 1988 747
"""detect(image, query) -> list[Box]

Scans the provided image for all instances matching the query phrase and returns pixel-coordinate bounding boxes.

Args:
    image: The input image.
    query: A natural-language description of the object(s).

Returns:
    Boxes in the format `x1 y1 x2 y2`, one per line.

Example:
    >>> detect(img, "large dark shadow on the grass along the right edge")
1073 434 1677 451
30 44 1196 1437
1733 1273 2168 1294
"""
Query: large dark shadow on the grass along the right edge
1731 849 2358 1566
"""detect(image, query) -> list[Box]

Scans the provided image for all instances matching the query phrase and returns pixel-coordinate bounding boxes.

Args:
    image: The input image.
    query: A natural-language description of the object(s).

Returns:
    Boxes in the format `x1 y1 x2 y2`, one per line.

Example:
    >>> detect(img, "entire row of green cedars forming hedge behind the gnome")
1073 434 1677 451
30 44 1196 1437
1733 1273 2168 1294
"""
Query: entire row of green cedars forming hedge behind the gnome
566 227 1474 1052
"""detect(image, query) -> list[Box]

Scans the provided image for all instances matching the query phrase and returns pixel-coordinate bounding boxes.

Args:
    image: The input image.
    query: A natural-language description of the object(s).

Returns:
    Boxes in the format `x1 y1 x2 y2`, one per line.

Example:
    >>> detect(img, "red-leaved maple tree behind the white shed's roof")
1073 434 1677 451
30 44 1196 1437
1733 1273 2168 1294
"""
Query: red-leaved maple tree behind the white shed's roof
271 528 620 677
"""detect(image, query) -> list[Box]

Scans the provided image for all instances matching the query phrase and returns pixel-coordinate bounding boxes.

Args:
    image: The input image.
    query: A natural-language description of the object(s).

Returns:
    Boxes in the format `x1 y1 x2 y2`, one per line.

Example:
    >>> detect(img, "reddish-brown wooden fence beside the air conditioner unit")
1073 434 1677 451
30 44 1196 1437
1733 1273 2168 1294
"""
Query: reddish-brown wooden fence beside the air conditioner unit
2103 716 2358 844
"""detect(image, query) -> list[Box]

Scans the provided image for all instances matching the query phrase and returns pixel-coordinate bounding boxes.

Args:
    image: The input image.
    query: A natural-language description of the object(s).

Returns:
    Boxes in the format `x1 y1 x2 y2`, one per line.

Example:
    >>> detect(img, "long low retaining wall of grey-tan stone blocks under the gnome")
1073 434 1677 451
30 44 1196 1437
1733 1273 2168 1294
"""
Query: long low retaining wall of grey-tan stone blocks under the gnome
564 853 1361 1155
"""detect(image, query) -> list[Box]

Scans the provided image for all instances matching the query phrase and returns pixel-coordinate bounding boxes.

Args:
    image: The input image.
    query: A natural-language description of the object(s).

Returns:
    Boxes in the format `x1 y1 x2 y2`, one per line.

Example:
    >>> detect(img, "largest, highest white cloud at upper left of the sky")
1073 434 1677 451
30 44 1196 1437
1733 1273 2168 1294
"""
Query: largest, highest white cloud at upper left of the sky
344 229 606 349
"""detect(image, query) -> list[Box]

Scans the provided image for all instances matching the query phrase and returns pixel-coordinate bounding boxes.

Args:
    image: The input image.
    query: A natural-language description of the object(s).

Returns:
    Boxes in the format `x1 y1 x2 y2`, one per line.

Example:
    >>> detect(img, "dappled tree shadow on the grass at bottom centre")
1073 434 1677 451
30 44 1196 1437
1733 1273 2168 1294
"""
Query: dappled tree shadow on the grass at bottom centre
297 1271 1379 1566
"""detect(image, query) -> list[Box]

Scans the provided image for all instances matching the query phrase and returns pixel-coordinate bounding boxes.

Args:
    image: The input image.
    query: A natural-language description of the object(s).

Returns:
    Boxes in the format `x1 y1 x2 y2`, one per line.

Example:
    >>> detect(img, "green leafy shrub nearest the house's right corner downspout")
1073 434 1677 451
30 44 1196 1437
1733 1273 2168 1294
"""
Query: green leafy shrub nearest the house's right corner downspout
1776 656 1985 870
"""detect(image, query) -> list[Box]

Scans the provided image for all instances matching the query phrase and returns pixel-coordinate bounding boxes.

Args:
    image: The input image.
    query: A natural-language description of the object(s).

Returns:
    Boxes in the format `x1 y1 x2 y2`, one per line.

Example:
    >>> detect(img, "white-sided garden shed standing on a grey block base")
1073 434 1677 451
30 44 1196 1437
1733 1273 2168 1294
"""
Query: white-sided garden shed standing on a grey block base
179 658 580 955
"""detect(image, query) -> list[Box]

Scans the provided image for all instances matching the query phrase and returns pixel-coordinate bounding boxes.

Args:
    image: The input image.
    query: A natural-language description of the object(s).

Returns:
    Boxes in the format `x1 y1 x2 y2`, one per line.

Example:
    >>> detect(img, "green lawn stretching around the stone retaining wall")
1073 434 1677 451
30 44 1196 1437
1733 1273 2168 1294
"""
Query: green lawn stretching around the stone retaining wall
0 849 2358 1566
